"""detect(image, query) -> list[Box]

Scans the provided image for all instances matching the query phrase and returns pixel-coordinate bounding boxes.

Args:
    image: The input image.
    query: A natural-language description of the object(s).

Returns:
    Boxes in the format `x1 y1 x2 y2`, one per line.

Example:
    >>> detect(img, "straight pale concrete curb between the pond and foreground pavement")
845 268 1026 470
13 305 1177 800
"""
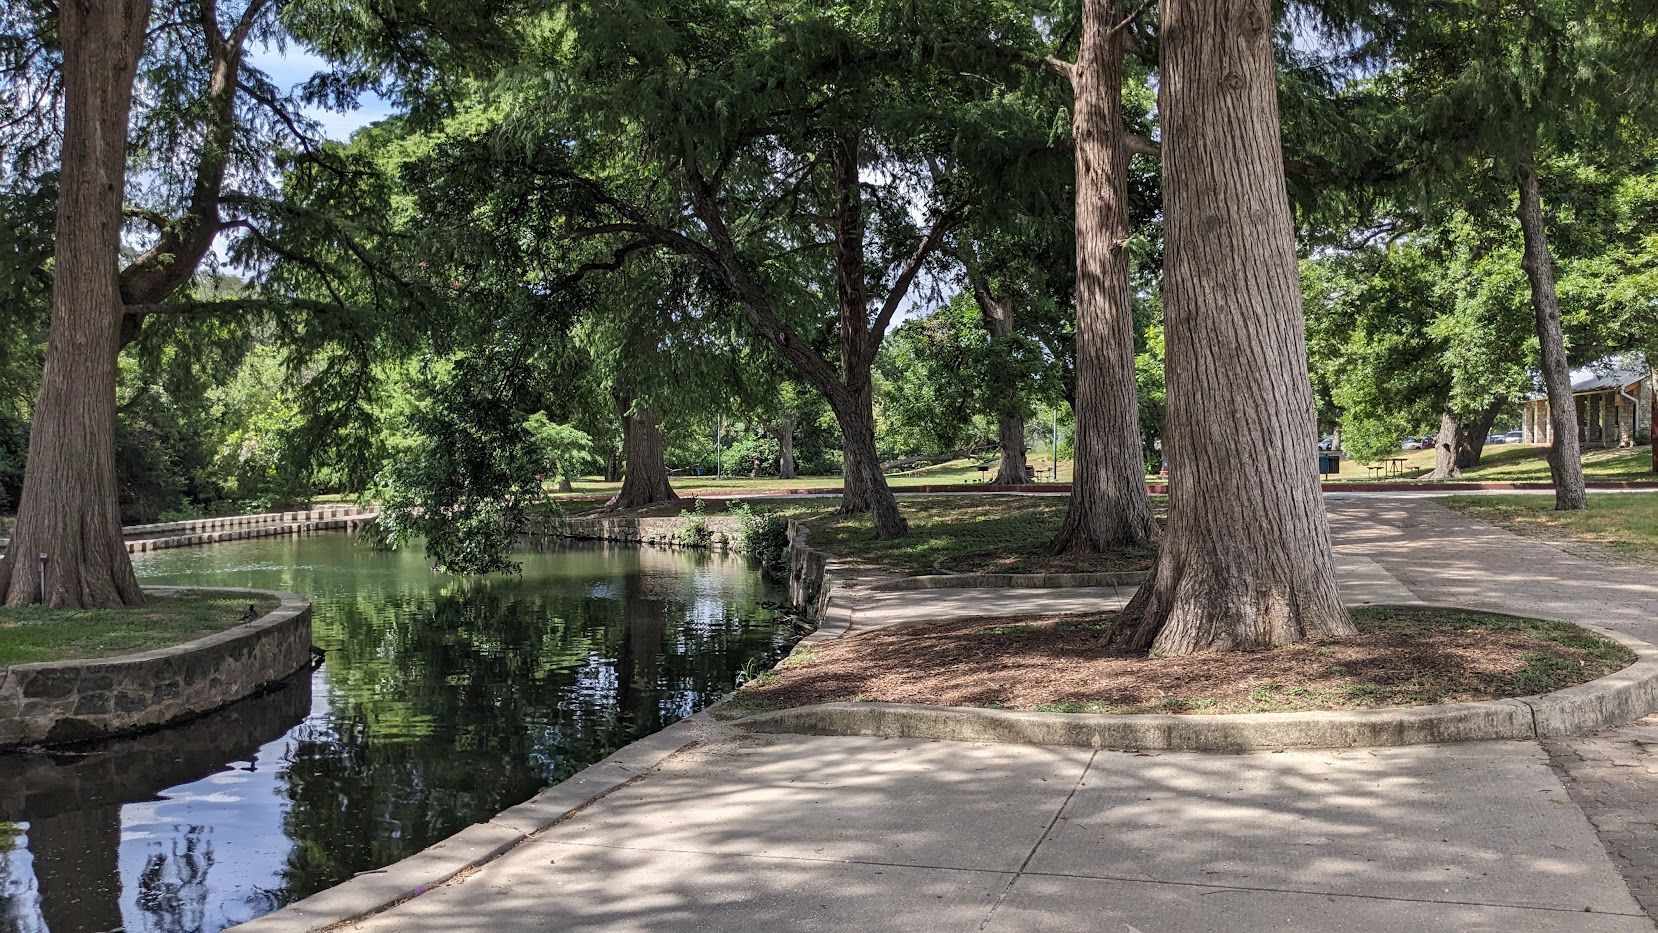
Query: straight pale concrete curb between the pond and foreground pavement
235 709 708 933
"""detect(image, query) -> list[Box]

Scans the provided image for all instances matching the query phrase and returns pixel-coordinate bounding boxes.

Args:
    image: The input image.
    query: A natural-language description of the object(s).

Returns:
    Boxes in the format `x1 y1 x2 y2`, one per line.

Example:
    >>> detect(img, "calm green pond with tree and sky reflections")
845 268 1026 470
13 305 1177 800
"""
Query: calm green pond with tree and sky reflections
0 534 789 933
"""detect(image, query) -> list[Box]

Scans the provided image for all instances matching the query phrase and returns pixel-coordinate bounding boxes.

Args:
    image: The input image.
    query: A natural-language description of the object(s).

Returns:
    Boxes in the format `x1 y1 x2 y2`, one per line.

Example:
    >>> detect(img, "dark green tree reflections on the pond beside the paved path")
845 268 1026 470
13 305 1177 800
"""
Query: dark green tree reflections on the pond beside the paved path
284 552 781 897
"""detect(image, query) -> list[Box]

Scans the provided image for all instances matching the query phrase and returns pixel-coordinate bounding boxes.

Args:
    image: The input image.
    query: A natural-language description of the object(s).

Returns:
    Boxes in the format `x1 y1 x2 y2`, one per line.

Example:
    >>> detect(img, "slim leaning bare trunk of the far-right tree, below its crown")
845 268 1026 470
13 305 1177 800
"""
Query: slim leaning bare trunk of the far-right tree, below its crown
1515 159 1588 512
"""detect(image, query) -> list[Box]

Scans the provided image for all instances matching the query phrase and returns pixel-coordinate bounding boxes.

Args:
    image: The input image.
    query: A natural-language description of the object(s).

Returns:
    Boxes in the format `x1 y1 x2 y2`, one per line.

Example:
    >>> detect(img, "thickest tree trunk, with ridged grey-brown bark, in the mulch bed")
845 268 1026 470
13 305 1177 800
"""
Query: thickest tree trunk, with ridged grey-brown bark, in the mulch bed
1113 0 1355 655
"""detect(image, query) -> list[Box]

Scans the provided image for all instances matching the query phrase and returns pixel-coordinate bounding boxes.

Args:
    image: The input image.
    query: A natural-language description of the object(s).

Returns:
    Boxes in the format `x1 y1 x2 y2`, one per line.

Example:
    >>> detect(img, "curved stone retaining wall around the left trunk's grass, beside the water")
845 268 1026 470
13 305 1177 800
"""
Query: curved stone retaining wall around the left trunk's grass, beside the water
0 587 312 749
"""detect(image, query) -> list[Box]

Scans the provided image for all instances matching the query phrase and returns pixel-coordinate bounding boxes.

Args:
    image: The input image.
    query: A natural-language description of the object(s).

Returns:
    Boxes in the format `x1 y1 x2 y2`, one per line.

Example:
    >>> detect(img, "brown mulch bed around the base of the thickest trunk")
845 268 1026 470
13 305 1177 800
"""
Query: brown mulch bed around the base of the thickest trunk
739 607 1635 713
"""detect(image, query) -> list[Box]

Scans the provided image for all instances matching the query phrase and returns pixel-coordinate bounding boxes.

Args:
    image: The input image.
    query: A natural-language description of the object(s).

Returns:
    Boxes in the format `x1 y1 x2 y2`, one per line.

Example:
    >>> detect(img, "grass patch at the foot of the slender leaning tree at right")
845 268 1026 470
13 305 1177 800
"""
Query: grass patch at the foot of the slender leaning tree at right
1441 492 1658 560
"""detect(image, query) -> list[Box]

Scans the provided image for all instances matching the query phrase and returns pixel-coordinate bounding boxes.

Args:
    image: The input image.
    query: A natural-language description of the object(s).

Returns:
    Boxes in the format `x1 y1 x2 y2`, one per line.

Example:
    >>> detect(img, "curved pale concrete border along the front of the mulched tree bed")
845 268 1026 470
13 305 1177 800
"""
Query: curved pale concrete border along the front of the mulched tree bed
731 603 1658 752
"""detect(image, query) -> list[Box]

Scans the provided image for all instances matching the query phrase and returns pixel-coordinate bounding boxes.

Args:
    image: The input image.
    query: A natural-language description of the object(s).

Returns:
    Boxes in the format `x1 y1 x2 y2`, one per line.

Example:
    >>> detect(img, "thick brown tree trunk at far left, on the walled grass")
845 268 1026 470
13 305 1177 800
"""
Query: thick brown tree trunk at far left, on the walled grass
0 0 149 608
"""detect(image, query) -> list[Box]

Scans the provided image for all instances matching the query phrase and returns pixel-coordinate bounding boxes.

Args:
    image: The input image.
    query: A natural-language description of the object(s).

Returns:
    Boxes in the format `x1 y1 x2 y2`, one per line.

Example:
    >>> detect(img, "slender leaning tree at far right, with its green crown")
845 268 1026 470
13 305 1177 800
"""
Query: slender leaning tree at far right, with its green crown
1370 0 1658 510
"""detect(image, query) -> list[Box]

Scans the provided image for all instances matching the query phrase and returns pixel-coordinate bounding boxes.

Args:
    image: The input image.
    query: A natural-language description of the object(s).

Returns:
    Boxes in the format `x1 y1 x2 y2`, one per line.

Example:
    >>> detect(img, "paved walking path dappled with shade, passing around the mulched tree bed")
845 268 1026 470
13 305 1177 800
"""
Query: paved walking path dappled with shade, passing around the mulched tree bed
333 499 1658 933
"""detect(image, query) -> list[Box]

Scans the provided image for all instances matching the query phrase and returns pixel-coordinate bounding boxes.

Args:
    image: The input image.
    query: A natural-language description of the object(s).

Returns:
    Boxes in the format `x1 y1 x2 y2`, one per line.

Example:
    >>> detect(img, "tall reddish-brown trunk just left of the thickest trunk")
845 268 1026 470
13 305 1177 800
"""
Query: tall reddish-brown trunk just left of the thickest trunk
1050 0 1159 554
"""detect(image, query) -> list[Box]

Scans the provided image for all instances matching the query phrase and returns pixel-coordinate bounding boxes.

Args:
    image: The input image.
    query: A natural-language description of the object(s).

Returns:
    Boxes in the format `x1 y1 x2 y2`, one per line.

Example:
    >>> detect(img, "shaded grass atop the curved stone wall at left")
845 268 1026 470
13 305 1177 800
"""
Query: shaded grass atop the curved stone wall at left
0 592 277 668
